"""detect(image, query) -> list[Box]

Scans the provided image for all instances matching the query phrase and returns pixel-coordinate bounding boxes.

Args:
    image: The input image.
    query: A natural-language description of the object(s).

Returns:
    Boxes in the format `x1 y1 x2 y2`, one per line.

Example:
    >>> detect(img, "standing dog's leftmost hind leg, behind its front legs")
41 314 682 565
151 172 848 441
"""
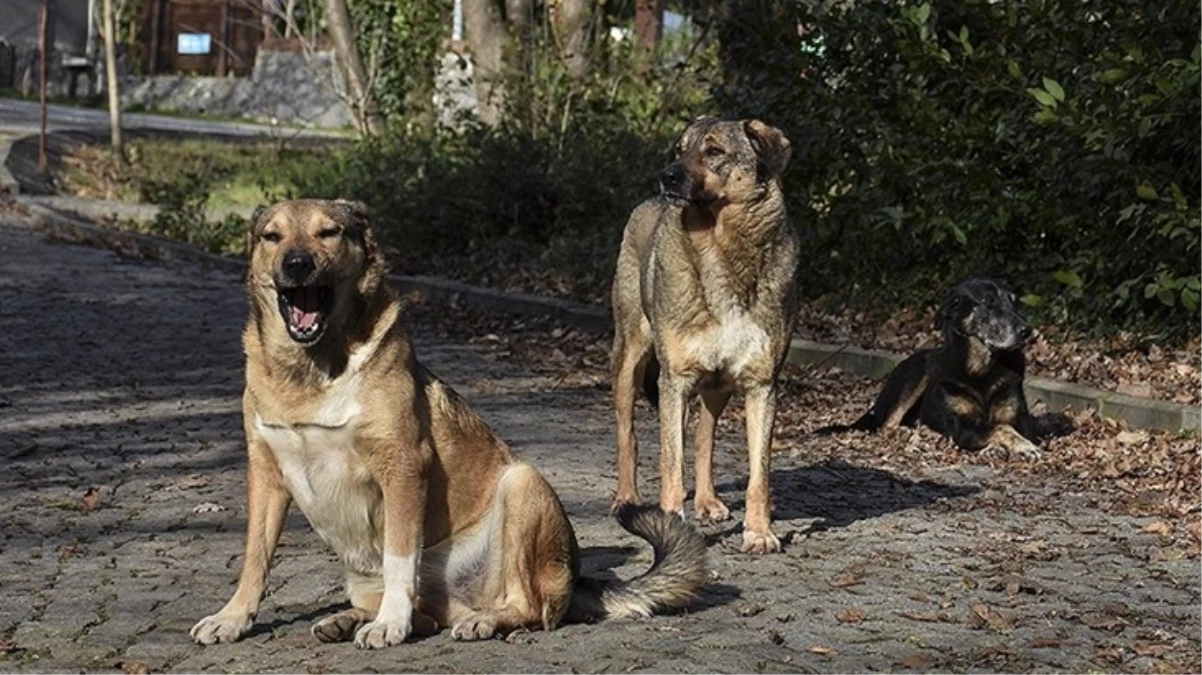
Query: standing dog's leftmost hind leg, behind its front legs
612 319 654 509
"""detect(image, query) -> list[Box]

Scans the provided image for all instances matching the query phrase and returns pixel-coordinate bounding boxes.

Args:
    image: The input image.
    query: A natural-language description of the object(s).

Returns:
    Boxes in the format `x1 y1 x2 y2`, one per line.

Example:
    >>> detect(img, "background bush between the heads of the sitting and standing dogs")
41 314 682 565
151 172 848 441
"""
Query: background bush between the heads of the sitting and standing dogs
292 28 713 298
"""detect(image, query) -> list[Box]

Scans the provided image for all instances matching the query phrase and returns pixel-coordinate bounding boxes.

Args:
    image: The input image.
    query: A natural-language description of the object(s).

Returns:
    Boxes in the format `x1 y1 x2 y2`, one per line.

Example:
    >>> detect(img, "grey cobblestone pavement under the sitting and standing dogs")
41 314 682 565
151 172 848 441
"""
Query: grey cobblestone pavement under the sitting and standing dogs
0 216 1202 673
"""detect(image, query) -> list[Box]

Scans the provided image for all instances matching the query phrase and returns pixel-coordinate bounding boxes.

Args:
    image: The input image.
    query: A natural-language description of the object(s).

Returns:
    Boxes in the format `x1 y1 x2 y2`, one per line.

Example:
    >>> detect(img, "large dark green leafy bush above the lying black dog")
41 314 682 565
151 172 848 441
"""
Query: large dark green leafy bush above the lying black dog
720 0 1202 331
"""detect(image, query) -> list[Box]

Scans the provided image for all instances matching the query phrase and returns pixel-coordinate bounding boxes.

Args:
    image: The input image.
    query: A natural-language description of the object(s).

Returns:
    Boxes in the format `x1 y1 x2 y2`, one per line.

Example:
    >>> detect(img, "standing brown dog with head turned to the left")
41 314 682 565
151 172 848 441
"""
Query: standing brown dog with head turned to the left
612 118 798 552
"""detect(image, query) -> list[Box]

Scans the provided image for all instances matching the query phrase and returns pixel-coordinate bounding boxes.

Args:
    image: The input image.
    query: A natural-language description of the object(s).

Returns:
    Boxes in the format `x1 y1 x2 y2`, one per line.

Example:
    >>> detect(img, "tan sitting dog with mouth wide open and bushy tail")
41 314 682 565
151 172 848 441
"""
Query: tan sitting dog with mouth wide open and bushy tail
191 201 707 649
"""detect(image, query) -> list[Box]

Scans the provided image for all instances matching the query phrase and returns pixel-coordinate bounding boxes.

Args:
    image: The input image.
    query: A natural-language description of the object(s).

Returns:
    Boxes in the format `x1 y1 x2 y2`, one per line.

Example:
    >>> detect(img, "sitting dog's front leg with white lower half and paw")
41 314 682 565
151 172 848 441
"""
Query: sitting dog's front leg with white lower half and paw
355 443 432 650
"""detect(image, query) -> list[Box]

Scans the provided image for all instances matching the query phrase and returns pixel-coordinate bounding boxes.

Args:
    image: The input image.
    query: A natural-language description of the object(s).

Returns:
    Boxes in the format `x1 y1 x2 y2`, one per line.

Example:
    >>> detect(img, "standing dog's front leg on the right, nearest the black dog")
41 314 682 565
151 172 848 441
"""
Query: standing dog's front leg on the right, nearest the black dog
743 384 780 554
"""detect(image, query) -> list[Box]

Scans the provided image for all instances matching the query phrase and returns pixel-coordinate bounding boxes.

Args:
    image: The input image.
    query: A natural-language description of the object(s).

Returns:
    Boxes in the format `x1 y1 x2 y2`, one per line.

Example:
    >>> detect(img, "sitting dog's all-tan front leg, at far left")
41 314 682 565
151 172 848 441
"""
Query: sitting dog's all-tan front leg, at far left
191 430 292 645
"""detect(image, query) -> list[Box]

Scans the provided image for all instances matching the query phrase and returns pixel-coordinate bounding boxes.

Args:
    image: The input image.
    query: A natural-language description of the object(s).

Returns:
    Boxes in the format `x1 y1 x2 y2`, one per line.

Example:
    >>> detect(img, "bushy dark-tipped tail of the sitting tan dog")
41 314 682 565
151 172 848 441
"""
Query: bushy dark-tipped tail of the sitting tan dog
567 504 709 622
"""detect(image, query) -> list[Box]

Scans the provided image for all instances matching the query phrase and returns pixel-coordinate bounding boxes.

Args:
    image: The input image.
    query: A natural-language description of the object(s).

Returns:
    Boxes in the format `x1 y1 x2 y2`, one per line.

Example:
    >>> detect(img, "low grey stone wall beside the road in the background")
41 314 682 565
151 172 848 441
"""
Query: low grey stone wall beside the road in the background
121 48 353 129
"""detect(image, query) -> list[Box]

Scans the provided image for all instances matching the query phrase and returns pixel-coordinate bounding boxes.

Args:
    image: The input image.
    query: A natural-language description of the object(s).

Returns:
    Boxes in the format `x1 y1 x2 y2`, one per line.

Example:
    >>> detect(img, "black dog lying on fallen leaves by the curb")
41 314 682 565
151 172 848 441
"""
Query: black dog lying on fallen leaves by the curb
817 279 1040 459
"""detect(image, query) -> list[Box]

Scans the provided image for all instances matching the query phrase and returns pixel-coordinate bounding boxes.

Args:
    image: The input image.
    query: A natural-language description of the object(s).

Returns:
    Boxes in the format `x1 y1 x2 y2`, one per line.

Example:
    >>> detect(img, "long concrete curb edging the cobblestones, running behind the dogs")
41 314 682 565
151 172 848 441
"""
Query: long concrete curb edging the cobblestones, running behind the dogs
17 197 1202 431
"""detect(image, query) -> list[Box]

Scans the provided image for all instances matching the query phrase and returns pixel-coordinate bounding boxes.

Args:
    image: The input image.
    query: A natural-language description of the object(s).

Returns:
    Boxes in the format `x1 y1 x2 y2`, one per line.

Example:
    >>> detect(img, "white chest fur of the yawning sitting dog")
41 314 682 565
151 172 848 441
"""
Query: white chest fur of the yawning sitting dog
254 372 383 575
